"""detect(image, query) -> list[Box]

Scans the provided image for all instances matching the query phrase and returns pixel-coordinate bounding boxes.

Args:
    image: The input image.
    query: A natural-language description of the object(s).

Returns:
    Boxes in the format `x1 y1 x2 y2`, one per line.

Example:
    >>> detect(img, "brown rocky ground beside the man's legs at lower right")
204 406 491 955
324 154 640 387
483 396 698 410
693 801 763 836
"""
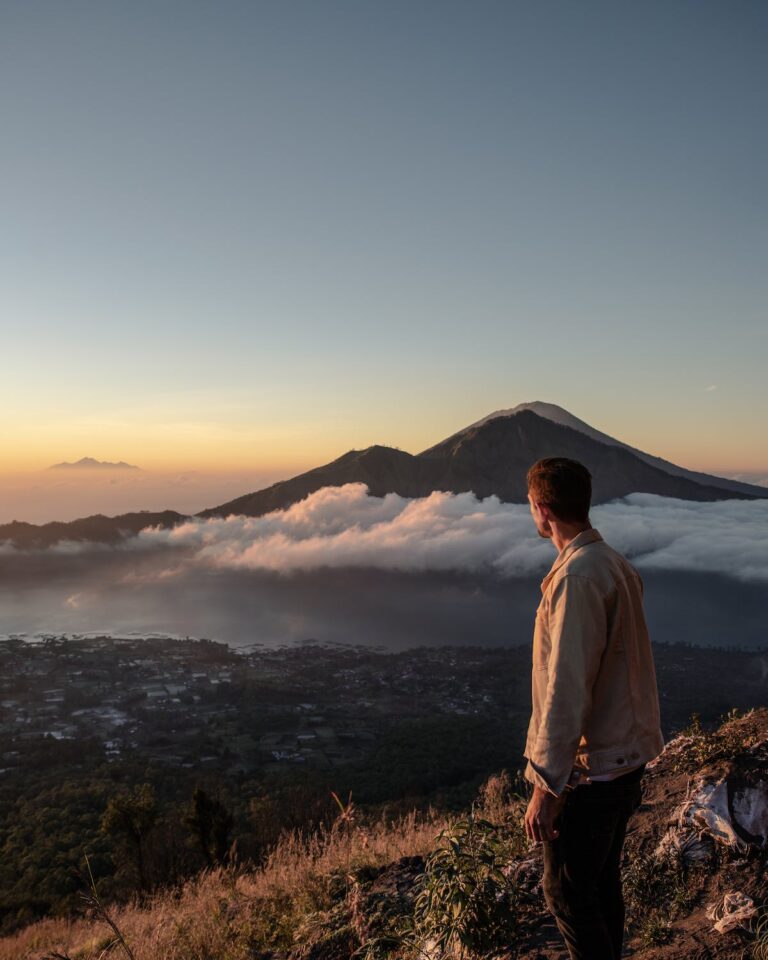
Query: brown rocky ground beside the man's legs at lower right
500 708 768 960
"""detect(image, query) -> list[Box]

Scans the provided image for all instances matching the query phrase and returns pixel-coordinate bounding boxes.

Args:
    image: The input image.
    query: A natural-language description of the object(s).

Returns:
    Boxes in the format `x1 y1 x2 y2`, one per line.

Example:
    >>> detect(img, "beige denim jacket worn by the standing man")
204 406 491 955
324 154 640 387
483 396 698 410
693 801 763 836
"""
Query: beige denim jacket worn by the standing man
524 528 664 796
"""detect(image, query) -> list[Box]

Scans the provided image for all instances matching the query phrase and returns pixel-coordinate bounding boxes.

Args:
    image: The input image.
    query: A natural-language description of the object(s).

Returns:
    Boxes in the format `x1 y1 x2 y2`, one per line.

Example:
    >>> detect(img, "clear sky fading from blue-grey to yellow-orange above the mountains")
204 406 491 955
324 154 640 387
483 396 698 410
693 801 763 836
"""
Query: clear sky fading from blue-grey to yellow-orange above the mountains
0 0 768 484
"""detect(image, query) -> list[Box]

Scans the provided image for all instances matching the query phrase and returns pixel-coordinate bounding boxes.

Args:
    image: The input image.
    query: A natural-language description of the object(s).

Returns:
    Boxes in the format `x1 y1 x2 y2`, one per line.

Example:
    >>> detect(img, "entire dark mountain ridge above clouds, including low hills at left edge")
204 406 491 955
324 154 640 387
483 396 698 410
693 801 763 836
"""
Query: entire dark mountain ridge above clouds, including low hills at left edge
0 401 768 549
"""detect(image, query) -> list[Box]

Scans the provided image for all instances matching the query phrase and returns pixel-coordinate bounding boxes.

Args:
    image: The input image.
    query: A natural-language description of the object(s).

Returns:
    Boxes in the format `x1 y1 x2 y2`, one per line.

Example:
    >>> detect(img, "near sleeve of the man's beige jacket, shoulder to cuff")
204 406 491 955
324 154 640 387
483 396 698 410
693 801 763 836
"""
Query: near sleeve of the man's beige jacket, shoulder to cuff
525 574 608 796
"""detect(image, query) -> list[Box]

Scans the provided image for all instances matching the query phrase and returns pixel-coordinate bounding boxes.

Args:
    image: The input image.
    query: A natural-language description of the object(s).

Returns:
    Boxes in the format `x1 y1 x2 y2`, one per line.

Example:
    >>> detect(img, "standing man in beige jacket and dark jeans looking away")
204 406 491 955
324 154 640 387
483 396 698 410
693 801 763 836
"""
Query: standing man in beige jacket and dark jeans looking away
524 457 664 960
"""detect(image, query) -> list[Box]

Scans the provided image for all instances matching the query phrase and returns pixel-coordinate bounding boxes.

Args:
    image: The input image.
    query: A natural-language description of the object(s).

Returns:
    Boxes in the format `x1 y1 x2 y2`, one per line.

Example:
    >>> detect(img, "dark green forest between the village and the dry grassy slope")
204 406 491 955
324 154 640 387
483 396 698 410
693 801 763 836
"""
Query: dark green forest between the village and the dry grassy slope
0 717 520 934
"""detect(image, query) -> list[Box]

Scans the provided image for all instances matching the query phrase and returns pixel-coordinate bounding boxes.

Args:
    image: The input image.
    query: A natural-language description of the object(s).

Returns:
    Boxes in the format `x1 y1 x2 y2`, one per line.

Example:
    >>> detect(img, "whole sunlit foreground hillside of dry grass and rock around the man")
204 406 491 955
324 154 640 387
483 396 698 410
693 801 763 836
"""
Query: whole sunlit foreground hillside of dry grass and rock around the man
6 707 768 960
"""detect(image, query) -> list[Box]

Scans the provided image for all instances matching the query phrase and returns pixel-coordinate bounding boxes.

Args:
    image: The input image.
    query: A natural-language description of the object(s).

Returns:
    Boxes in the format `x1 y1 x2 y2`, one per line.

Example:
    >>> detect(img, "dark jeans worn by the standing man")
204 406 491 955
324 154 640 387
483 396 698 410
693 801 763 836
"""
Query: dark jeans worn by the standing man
542 764 645 960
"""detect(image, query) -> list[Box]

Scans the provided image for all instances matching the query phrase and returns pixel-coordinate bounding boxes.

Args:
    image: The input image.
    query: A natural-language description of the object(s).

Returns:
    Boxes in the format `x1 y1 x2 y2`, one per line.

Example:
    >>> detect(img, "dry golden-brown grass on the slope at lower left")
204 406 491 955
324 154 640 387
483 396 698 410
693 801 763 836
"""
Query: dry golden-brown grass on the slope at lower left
0 809 456 960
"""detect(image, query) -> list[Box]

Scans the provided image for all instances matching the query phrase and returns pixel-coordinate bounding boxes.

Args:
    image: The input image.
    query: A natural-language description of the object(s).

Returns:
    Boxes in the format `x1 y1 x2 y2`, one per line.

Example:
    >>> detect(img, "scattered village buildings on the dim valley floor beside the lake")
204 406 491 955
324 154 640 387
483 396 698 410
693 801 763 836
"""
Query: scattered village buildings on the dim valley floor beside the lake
0 635 528 776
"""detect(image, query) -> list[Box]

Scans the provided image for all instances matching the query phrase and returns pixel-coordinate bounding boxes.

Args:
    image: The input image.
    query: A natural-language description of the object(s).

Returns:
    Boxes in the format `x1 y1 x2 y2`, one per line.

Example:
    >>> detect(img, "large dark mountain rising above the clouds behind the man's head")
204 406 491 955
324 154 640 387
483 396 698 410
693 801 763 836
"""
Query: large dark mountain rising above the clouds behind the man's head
197 405 768 517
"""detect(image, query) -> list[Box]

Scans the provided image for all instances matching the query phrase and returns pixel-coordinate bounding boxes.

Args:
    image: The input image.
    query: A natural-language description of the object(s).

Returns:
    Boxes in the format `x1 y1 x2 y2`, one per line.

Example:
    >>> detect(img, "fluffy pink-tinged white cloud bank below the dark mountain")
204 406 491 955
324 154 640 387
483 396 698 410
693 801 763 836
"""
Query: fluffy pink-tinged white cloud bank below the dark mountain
121 483 768 582
